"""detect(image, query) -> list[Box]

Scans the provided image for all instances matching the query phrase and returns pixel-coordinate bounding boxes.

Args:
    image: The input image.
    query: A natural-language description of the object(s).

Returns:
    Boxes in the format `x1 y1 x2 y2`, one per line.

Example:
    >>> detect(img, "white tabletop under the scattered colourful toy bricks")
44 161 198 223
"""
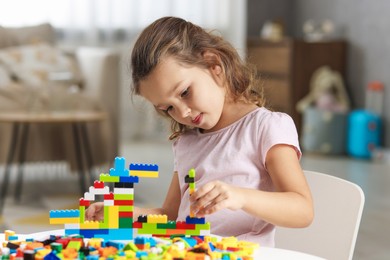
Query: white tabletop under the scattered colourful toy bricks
0 229 323 260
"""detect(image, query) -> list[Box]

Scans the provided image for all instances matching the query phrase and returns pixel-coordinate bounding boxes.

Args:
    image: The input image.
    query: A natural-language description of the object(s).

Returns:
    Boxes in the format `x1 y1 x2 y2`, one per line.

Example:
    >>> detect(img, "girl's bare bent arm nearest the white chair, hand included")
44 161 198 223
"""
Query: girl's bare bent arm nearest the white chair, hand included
190 145 314 227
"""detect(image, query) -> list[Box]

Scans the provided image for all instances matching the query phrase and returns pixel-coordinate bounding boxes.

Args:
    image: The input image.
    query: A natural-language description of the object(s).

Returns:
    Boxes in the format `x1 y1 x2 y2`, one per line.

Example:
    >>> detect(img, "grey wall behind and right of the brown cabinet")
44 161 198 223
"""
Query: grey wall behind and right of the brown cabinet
248 0 390 147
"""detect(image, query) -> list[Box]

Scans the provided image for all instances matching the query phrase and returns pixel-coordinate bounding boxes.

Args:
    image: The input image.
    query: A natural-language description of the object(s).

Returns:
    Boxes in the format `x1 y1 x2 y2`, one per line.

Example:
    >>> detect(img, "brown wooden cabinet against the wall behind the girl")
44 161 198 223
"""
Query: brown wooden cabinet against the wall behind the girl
247 38 346 131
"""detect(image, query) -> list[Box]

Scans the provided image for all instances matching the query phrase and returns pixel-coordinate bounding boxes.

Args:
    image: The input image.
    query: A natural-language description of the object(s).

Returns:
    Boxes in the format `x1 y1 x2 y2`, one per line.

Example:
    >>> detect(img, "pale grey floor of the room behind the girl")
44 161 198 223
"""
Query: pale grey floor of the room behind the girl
0 142 390 260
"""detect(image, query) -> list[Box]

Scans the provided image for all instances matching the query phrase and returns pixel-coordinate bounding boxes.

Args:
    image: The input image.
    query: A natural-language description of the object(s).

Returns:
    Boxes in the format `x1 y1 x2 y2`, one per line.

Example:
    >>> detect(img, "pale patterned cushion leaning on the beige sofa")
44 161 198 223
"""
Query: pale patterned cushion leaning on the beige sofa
0 43 81 87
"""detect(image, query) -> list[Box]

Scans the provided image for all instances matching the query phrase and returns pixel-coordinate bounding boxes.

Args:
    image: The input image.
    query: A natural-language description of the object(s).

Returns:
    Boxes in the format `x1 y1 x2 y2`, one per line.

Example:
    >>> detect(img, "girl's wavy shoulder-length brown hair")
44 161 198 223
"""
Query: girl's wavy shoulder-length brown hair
131 17 264 139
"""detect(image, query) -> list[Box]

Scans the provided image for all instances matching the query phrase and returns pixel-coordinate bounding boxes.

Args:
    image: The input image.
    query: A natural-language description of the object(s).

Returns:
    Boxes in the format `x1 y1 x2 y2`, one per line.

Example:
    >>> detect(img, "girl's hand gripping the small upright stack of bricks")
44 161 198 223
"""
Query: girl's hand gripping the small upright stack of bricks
190 181 244 217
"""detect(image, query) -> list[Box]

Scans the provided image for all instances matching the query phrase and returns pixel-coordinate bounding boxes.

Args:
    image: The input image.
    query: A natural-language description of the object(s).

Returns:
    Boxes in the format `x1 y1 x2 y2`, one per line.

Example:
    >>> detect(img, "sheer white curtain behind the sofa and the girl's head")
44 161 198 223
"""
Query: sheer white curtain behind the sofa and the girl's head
0 0 247 140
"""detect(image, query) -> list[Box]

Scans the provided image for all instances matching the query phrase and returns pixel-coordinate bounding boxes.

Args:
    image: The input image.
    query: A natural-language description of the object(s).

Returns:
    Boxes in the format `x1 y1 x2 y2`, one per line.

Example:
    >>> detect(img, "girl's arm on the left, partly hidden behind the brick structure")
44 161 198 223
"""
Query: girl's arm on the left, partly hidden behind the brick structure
85 172 181 221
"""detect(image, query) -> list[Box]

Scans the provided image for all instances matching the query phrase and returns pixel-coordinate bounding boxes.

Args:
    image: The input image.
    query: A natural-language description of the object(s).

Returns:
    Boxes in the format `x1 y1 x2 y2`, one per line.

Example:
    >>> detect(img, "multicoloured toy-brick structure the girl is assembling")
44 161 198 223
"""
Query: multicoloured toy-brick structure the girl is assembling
50 157 210 241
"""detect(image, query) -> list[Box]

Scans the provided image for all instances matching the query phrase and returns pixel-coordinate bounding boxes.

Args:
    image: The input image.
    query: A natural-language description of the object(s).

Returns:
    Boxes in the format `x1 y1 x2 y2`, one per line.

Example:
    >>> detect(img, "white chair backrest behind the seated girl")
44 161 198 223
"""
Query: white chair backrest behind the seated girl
275 171 364 260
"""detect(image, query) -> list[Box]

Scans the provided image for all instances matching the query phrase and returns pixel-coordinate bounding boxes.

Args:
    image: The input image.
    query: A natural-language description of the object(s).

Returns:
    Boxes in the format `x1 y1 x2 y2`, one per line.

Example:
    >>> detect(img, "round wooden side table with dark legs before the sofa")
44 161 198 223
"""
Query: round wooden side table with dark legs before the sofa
0 111 107 215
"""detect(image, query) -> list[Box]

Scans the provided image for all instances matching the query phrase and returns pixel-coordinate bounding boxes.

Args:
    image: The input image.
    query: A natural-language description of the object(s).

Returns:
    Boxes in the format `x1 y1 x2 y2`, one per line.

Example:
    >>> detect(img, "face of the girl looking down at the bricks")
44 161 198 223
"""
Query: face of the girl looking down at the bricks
140 57 226 131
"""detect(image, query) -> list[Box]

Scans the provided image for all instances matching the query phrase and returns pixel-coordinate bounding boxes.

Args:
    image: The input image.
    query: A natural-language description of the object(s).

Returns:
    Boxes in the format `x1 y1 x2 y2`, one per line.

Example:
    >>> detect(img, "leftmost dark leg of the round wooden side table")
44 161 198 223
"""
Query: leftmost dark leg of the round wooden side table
0 123 19 215
